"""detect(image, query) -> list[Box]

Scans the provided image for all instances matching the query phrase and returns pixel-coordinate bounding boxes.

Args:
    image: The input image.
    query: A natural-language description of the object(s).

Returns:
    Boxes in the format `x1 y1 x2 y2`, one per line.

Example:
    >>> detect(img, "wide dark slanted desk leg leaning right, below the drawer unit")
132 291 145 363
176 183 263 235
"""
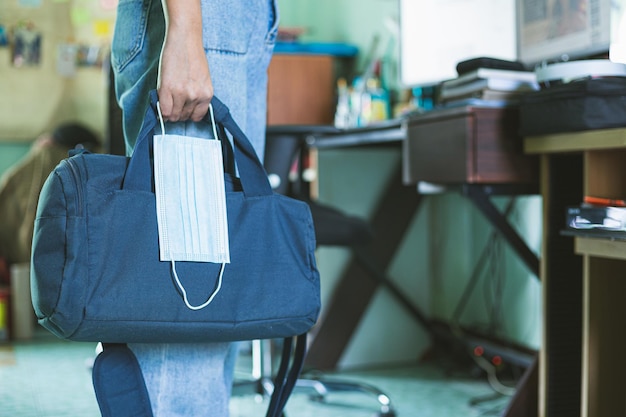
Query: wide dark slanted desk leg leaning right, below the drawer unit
306 167 421 369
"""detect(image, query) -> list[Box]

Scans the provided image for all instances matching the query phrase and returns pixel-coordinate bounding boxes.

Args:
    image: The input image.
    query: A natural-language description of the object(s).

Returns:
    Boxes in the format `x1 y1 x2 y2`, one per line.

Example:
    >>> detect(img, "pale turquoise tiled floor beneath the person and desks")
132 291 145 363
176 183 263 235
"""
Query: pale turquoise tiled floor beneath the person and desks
0 333 509 417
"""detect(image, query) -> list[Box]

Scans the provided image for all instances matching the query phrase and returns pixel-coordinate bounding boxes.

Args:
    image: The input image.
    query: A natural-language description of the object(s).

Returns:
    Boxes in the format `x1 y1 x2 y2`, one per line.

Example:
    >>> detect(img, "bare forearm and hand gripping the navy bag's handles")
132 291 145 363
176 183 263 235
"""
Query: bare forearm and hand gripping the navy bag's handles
157 0 213 122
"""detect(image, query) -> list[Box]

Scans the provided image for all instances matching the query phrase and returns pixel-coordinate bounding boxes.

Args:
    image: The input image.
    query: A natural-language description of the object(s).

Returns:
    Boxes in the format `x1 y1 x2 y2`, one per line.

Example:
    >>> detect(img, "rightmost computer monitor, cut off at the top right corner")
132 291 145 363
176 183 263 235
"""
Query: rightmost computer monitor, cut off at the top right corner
516 0 626 67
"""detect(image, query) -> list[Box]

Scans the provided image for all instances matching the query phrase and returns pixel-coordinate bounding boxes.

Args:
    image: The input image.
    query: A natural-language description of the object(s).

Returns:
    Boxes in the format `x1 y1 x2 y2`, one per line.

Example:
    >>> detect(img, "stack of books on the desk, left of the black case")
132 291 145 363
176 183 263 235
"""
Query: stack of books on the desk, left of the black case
439 68 539 105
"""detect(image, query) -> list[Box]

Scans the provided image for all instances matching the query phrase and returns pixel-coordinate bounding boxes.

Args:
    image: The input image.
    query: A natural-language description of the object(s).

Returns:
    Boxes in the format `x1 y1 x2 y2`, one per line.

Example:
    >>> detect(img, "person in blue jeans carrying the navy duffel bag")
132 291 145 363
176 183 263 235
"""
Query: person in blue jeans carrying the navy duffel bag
111 0 278 417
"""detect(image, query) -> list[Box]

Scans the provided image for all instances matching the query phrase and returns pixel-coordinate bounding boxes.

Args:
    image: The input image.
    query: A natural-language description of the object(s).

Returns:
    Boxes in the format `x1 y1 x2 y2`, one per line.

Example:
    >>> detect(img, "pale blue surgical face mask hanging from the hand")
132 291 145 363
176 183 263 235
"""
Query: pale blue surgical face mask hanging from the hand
154 104 230 309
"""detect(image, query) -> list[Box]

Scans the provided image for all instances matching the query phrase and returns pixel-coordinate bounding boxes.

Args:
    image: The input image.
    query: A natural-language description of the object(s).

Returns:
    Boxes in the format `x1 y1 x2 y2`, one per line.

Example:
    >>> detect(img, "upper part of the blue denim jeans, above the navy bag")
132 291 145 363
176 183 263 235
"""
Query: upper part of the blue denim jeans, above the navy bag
111 0 278 160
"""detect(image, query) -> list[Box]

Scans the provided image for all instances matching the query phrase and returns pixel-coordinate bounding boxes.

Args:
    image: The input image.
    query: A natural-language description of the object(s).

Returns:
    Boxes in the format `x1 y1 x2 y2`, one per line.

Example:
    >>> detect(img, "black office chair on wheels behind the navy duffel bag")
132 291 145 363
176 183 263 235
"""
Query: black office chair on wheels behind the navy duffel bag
235 125 396 417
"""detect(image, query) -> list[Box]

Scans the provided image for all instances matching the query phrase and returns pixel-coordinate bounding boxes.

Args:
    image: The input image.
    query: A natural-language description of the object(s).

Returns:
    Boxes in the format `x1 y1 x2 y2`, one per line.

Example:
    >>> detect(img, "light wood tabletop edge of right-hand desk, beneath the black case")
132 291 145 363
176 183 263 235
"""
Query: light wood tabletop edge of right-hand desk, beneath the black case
524 128 626 154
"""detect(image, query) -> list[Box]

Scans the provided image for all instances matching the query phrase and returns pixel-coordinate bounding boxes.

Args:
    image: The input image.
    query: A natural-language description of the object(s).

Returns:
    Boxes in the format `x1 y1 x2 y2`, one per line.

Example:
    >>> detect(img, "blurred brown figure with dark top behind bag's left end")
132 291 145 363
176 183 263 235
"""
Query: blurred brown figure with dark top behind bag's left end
0 122 100 265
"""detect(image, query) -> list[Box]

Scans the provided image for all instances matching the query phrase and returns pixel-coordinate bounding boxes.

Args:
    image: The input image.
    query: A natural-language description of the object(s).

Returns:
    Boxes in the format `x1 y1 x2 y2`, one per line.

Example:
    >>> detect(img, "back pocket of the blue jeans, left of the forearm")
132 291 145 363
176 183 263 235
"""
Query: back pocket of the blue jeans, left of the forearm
111 0 152 71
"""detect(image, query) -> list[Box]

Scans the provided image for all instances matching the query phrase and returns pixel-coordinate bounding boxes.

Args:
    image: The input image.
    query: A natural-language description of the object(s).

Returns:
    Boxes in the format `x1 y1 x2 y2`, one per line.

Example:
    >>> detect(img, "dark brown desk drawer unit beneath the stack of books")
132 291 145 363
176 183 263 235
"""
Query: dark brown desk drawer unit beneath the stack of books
403 107 538 184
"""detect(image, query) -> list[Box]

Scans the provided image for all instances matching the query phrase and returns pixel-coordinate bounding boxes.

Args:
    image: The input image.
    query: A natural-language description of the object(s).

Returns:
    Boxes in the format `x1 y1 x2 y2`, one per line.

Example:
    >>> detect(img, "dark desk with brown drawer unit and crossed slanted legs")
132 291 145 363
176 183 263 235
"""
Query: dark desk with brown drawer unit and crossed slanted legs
307 107 539 386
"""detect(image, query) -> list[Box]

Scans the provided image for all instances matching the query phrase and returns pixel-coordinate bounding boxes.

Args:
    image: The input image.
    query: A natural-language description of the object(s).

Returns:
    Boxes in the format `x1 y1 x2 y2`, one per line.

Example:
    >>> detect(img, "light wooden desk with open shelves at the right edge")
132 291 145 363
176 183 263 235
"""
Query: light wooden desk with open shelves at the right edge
525 129 626 417
